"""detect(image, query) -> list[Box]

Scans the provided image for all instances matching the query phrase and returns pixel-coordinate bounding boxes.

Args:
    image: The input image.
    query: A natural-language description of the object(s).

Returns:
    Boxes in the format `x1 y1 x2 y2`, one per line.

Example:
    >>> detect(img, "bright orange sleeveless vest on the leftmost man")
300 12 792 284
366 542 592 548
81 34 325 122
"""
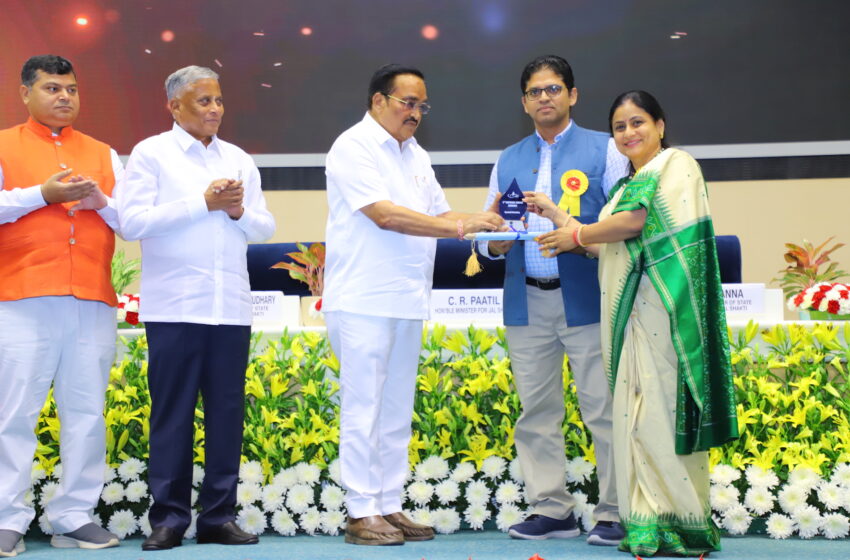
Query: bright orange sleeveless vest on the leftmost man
0 118 117 307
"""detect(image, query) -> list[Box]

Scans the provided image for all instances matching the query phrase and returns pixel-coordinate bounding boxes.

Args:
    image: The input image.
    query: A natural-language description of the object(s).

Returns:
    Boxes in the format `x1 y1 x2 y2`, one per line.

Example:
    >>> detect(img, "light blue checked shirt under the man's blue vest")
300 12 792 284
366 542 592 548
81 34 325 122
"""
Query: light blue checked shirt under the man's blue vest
478 119 629 279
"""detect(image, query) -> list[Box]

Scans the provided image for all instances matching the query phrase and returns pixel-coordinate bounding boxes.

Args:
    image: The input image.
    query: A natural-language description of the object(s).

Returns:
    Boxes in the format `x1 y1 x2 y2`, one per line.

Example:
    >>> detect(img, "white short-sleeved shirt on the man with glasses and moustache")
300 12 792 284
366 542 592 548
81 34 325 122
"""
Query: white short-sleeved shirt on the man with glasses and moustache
322 113 451 319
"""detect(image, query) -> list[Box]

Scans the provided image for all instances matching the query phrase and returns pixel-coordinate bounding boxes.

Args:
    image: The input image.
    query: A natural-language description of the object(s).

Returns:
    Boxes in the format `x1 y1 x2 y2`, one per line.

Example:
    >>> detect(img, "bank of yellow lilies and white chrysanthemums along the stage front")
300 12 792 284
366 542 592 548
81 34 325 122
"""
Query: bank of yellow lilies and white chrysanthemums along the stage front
27 324 850 539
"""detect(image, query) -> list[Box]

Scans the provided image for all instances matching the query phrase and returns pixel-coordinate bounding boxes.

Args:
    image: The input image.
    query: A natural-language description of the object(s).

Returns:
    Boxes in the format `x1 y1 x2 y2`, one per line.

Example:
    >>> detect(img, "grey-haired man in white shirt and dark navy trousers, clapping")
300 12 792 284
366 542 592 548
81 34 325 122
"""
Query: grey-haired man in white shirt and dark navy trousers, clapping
117 66 275 550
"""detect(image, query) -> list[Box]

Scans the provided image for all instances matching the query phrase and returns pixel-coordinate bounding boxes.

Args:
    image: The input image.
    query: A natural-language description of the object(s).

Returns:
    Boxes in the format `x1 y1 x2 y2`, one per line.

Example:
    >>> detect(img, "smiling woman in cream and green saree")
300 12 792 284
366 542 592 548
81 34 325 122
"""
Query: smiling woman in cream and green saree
525 91 738 556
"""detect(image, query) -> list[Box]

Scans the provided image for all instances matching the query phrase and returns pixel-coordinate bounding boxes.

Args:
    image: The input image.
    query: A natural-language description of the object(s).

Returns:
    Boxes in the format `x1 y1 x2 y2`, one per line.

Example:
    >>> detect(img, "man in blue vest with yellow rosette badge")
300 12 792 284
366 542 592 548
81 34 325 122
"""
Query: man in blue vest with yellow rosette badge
478 55 628 546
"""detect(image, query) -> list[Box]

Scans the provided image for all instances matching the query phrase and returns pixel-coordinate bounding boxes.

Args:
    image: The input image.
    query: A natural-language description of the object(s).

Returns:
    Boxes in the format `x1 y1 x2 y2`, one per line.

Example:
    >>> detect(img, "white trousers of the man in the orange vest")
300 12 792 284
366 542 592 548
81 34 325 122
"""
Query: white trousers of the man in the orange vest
0 296 115 533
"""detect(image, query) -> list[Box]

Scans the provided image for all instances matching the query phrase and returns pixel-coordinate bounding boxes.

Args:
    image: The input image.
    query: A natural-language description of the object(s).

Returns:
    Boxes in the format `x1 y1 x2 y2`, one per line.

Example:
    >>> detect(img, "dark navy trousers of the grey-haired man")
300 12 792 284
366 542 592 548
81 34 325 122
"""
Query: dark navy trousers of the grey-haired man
145 322 251 533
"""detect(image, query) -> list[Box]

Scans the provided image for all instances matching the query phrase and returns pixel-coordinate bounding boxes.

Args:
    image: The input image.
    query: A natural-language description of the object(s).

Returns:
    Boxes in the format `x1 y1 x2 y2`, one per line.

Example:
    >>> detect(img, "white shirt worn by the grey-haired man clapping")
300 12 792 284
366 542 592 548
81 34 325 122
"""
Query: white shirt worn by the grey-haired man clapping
116 123 275 325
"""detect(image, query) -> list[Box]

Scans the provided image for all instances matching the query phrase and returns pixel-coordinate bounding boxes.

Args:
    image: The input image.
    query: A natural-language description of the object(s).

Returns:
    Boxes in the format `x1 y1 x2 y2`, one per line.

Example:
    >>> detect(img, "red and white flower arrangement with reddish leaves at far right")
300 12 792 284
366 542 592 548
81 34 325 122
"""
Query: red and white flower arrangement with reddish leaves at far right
774 237 850 319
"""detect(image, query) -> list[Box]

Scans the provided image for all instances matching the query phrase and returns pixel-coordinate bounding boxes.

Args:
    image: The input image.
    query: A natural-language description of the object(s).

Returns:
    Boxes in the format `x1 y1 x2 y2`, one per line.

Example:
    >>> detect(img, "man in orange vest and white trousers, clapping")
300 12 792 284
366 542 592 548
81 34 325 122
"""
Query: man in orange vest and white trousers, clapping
0 55 123 557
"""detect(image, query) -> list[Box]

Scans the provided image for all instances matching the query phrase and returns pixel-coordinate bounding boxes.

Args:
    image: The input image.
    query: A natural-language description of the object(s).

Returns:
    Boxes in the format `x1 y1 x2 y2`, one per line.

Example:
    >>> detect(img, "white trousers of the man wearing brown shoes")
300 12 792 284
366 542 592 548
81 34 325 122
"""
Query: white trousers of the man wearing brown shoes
325 311 422 518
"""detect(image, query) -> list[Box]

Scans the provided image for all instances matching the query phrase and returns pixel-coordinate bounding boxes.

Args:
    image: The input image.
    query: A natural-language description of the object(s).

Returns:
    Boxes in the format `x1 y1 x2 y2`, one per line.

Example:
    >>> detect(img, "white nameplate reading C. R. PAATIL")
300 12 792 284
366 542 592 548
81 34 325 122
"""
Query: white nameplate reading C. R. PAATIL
431 288 502 326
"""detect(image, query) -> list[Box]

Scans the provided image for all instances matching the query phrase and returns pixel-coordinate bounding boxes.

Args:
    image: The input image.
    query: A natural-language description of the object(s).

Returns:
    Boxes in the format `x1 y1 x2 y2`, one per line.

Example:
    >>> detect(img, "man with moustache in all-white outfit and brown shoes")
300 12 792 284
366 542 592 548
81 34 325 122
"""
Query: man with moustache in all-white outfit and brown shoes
322 64 501 545
